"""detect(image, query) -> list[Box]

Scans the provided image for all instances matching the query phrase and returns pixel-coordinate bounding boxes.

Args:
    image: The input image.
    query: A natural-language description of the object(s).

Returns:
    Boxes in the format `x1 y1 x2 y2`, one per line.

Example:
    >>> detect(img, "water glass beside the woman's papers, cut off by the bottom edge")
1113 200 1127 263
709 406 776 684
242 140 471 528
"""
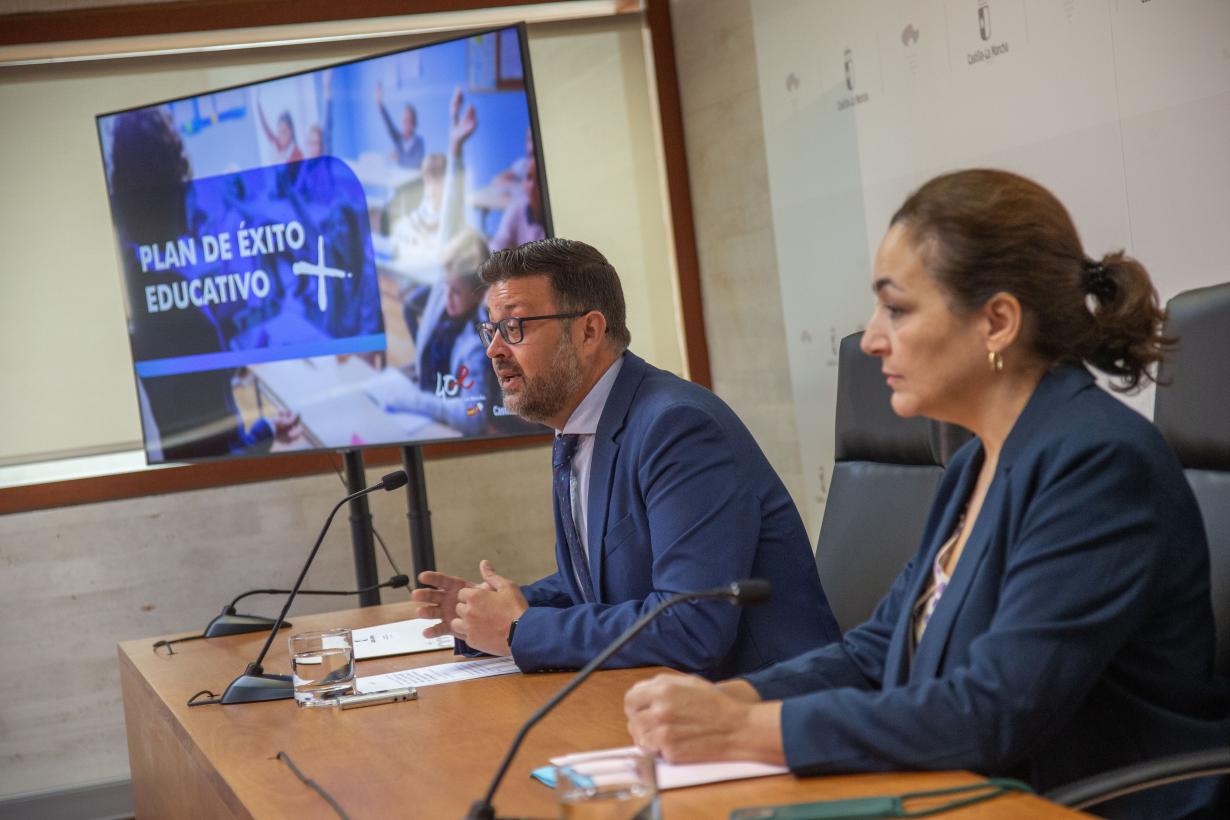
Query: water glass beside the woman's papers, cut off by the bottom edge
555 749 662 820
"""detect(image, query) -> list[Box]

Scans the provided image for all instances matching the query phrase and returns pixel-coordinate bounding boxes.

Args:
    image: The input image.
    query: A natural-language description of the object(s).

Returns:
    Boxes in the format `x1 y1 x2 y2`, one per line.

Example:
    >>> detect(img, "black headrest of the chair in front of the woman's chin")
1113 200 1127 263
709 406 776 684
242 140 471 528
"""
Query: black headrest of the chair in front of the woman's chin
834 332 970 466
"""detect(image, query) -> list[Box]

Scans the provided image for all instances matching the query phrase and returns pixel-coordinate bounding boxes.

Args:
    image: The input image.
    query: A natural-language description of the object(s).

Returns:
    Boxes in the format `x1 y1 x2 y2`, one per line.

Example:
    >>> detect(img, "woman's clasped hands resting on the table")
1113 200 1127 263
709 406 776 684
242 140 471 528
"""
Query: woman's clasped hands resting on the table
624 674 785 765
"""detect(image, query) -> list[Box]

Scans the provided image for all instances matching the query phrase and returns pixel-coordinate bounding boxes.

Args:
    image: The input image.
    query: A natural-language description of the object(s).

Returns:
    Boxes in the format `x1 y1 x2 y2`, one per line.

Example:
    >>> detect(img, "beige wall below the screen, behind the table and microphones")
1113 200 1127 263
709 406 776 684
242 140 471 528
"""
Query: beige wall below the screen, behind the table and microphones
0 446 555 798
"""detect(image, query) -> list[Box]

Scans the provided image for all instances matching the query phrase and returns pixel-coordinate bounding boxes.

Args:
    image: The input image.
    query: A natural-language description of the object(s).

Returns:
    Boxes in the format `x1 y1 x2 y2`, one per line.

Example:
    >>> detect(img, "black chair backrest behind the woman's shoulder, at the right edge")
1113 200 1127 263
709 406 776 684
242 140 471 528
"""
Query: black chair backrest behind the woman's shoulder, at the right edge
1154 283 1230 680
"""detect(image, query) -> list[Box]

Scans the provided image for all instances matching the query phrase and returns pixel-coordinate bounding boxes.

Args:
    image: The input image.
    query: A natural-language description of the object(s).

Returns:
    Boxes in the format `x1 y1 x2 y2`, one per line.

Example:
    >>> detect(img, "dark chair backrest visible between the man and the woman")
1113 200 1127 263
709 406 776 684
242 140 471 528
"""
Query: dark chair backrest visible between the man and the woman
815 333 970 632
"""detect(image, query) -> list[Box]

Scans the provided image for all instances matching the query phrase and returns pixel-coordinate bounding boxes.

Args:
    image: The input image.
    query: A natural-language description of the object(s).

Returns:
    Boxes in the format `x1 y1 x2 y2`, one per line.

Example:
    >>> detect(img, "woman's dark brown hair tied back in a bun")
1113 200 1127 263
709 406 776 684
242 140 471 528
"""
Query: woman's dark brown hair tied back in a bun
891 170 1173 391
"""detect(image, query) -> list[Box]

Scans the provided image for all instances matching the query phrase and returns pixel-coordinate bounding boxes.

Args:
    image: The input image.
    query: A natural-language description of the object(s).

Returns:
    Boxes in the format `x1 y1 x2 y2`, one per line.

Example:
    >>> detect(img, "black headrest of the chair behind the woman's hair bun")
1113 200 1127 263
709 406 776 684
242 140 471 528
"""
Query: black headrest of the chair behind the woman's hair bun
1154 283 1230 471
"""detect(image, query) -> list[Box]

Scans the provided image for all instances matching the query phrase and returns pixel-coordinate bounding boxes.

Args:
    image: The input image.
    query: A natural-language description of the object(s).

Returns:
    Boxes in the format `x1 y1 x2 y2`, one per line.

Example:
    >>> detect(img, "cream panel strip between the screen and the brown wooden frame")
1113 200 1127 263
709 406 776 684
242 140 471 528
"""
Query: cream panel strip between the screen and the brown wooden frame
531 21 684 374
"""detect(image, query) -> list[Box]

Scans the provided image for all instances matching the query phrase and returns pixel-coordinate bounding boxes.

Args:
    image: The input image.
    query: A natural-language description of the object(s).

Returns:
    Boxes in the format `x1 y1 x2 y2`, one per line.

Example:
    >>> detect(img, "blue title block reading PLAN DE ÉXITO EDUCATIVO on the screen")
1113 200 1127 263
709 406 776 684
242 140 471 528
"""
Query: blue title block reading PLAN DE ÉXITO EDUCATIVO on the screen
112 156 386 377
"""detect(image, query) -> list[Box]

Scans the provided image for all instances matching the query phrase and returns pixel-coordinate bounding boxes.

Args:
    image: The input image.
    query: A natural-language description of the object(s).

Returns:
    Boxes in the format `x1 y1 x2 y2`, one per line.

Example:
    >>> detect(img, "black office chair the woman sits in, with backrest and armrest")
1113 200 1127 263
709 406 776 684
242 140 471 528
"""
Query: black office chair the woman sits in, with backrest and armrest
1046 283 1230 809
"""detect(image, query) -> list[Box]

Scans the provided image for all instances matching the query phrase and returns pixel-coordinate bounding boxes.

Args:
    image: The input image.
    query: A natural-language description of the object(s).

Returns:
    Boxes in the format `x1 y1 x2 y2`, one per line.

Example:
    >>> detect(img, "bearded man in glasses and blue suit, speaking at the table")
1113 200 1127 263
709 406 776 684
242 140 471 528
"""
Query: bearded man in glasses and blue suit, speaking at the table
415 240 840 677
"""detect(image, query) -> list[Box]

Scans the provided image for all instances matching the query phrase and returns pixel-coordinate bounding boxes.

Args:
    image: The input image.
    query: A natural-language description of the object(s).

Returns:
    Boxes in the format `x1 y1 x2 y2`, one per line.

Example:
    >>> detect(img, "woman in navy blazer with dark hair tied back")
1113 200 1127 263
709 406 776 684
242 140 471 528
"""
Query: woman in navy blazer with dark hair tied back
625 171 1230 818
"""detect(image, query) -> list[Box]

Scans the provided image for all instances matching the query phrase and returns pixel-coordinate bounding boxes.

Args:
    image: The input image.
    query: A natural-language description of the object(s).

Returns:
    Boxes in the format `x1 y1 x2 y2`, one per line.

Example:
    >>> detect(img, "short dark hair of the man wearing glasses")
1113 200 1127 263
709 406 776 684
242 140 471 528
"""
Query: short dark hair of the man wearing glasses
478 239 632 350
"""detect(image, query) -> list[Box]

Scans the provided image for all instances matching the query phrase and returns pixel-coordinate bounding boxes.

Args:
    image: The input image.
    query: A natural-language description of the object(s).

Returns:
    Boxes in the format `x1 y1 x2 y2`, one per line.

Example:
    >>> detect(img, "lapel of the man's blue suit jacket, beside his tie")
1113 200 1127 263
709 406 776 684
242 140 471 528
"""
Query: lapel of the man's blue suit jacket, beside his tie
585 352 647 601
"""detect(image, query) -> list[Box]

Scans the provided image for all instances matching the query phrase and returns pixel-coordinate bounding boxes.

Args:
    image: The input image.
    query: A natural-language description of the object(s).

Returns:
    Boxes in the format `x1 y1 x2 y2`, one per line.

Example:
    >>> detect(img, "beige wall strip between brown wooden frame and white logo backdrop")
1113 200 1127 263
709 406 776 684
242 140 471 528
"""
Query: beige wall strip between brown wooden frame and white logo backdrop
670 0 819 526
